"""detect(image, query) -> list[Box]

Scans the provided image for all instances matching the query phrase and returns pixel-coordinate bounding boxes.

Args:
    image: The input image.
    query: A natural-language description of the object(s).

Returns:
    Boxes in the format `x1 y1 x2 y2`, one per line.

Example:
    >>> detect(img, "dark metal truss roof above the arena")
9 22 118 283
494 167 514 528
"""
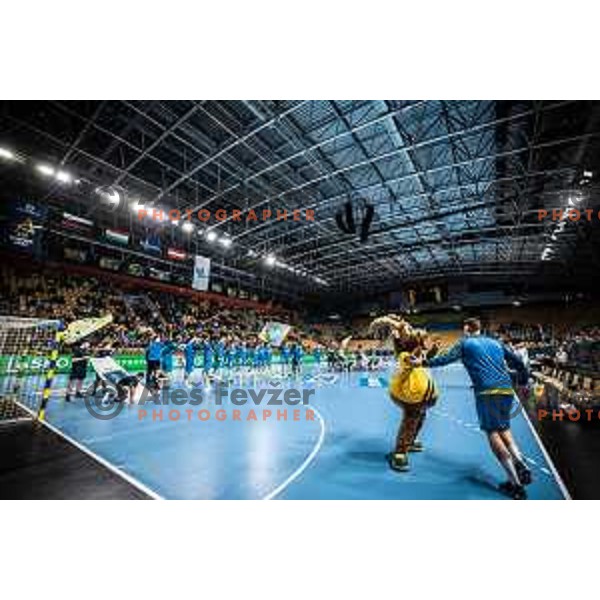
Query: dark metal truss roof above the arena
0 100 600 302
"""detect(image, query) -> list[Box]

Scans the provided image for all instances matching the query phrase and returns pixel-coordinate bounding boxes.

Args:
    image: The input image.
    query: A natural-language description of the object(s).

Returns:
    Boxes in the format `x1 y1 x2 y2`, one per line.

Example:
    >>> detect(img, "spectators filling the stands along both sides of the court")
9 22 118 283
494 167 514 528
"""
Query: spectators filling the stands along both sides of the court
0 264 600 386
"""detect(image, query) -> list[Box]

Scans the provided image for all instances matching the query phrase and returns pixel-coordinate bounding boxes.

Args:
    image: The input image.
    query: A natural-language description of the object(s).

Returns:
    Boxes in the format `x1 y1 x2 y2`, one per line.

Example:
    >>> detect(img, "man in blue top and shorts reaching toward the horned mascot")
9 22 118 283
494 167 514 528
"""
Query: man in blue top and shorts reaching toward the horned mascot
428 319 531 500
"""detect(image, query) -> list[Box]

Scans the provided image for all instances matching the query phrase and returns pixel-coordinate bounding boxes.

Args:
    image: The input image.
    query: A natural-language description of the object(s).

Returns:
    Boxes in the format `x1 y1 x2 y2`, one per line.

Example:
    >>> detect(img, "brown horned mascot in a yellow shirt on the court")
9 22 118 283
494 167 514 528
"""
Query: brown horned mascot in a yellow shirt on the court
372 315 438 471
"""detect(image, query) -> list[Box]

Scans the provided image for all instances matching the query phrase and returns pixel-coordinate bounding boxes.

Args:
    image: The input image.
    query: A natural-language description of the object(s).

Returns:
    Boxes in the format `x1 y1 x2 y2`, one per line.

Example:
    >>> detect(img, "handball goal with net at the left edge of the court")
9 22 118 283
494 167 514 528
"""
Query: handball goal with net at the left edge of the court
0 316 60 425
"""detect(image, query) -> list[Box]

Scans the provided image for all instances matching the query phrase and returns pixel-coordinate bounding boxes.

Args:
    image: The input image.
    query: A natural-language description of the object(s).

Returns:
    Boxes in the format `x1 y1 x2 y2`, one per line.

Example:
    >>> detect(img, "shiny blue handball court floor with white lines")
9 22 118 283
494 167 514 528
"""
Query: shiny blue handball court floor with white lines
35 365 567 500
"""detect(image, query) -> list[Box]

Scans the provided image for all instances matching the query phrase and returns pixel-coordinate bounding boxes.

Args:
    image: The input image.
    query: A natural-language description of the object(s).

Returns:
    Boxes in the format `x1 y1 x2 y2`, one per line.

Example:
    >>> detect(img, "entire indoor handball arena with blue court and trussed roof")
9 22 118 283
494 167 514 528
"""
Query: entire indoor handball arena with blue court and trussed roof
0 100 600 500
